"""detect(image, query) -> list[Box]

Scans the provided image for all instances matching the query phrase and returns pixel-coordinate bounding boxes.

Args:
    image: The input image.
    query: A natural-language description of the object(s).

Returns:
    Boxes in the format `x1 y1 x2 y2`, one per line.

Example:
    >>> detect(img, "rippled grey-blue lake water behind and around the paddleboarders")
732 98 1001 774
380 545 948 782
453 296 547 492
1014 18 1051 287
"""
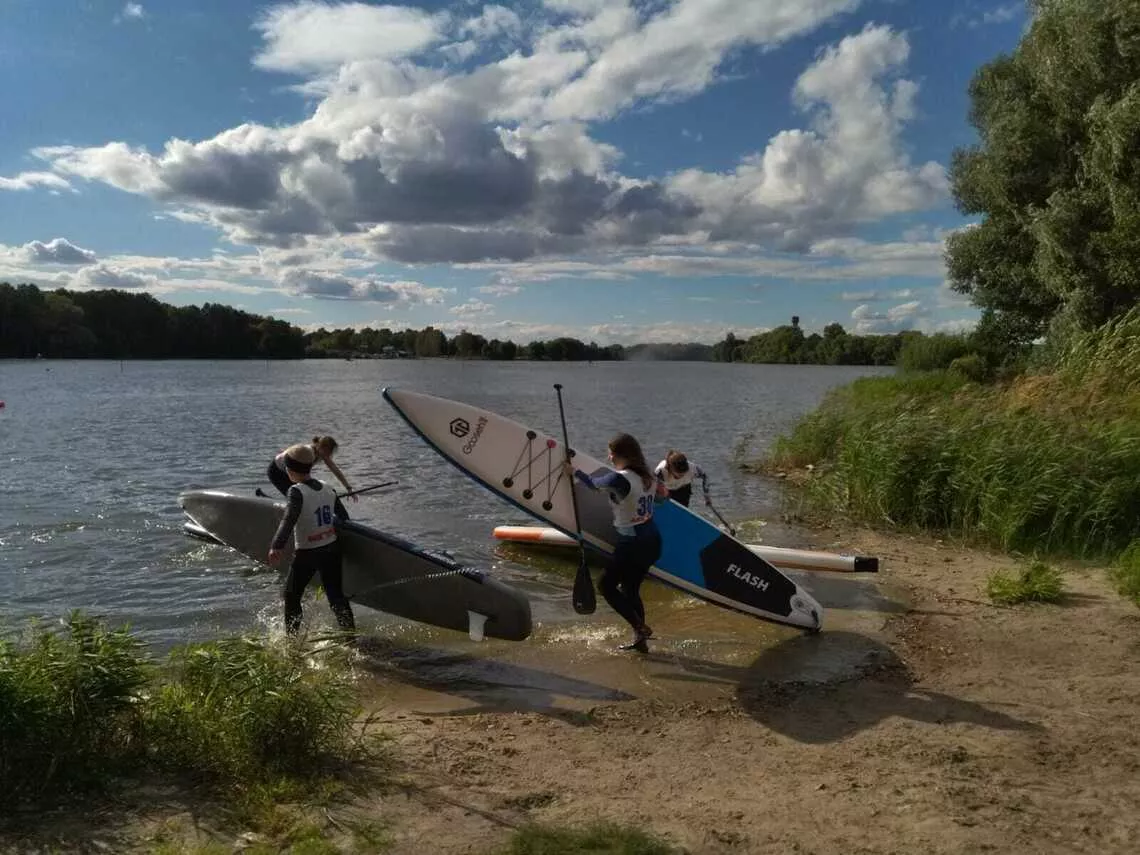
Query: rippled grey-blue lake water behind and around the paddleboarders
0 360 893 649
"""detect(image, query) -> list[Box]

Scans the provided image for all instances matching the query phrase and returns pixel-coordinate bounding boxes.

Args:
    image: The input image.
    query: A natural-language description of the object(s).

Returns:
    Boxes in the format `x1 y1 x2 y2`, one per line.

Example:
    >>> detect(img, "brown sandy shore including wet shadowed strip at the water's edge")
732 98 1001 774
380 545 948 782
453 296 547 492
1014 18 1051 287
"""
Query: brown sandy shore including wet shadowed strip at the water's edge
0 526 1140 855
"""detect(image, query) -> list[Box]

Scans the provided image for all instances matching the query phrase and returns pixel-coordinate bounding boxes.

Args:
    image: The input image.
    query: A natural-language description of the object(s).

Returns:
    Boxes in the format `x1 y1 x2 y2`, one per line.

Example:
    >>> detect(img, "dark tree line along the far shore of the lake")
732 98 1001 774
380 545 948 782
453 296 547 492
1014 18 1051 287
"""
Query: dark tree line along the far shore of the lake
0 283 922 365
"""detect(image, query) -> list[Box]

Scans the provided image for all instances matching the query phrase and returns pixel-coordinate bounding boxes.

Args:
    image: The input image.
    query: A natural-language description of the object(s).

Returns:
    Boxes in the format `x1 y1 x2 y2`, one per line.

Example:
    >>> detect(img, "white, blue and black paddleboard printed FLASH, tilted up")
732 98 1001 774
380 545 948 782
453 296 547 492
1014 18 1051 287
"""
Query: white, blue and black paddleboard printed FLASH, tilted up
383 389 823 632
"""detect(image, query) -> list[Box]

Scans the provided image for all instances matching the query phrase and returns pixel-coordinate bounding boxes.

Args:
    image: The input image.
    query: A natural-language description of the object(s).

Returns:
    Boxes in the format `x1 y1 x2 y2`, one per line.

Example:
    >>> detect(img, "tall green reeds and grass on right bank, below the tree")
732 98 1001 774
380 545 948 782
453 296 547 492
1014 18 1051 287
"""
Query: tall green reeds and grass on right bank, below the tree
770 311 1140 555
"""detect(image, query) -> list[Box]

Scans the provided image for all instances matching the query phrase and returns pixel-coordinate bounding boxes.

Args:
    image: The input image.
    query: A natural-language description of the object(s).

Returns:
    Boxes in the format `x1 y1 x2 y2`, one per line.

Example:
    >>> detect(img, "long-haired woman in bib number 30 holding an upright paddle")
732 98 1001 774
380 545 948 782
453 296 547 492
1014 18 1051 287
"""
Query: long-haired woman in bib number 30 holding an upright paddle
563 433 665 653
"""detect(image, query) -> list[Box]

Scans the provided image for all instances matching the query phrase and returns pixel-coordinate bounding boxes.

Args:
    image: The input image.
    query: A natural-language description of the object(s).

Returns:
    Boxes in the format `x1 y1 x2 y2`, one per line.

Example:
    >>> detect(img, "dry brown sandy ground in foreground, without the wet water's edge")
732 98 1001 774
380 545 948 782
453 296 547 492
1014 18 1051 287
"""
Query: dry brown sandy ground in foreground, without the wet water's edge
369 531 1140 855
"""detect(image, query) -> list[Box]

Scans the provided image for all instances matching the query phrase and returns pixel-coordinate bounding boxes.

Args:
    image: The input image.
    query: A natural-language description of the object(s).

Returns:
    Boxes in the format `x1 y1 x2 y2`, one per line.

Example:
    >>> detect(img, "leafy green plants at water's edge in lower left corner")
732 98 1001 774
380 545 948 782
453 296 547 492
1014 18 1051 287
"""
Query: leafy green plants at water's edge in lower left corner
0 612 359 805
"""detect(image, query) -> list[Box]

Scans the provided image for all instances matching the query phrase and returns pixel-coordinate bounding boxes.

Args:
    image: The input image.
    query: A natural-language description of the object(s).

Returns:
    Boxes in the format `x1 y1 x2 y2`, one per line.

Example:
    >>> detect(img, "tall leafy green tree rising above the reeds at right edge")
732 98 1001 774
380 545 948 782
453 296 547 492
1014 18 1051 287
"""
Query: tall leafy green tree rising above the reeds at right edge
946 0 1140 352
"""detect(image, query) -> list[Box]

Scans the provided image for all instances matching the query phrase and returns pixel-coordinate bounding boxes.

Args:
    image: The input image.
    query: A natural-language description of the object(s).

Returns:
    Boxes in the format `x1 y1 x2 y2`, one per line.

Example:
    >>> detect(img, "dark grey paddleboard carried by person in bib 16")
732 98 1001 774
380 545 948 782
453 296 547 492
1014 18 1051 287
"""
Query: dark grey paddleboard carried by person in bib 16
178 490 531 641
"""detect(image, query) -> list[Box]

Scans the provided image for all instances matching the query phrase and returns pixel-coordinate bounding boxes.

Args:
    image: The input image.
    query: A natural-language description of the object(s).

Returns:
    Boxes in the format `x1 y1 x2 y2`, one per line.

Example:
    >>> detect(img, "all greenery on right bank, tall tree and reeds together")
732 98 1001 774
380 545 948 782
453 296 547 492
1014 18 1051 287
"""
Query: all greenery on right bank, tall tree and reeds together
765 0 1140 597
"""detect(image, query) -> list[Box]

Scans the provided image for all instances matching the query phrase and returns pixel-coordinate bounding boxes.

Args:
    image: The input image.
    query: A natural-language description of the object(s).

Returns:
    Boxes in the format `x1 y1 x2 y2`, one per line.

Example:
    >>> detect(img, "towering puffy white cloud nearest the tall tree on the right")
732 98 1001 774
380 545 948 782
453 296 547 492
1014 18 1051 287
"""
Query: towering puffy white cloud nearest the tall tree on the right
669 25 948 250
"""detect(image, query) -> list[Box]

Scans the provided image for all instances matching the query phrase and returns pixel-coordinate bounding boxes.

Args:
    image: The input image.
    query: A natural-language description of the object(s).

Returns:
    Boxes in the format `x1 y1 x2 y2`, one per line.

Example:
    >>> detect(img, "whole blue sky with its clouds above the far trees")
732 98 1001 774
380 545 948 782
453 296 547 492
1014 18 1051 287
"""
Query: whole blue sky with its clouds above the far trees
0 0 1027 344
